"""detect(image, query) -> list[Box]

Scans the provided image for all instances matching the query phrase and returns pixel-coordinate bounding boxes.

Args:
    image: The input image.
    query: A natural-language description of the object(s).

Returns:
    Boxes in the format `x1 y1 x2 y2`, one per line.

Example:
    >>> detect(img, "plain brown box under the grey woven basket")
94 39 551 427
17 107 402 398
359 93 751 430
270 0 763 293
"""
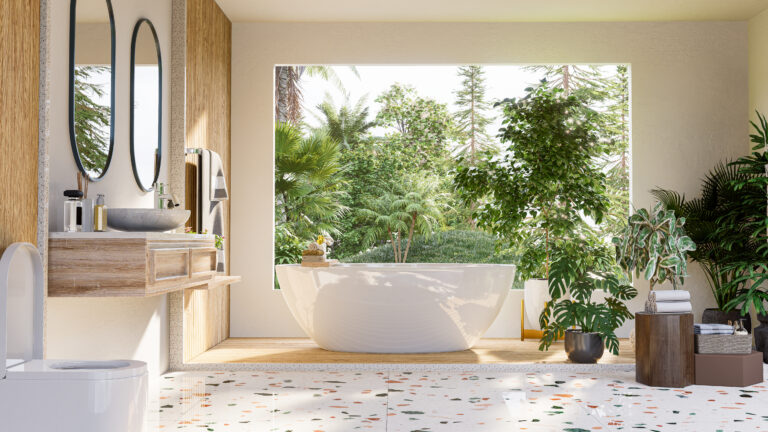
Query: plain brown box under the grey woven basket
694 352 763 387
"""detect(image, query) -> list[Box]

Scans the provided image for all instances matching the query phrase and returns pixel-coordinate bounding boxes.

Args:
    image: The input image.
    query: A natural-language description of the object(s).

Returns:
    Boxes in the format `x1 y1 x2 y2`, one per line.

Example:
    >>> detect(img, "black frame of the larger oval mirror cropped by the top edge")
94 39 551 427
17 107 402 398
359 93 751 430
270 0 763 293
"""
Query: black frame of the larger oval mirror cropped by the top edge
69 0 116 182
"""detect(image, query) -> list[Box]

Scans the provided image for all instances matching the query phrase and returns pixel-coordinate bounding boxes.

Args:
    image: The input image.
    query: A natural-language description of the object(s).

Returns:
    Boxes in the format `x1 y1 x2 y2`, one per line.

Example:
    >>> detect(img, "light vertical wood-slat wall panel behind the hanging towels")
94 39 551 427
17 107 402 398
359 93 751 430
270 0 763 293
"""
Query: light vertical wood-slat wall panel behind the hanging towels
184 0 232 361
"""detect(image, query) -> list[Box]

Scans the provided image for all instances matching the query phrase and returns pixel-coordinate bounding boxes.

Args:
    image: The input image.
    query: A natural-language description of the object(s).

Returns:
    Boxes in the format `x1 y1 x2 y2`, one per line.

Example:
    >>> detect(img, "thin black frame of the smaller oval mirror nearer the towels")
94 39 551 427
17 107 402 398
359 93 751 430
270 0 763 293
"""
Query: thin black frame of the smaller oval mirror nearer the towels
129 18 163 192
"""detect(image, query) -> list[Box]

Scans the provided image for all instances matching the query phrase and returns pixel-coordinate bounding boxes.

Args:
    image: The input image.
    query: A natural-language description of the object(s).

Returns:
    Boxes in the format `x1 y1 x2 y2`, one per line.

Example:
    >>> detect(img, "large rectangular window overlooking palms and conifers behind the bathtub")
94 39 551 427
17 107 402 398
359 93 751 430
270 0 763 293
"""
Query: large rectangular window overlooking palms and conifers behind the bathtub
275 65 630 284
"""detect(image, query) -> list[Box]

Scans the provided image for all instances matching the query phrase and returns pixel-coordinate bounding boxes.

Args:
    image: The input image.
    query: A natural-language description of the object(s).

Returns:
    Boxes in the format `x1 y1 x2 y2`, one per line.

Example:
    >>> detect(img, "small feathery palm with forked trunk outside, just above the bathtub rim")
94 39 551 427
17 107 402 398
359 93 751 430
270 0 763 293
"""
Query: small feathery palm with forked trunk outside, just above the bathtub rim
358 177 445 263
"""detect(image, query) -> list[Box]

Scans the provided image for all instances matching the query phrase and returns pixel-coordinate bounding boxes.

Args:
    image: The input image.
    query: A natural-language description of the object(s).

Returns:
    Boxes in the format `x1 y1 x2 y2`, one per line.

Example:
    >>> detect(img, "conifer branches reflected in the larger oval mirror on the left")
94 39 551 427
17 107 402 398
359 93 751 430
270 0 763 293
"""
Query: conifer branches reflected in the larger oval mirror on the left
74 66 111 177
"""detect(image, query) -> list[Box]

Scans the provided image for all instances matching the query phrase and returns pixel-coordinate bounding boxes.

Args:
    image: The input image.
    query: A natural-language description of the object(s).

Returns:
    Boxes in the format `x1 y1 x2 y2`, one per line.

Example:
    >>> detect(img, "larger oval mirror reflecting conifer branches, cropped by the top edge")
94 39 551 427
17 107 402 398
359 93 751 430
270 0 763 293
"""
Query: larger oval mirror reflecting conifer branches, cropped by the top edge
69 0 115 181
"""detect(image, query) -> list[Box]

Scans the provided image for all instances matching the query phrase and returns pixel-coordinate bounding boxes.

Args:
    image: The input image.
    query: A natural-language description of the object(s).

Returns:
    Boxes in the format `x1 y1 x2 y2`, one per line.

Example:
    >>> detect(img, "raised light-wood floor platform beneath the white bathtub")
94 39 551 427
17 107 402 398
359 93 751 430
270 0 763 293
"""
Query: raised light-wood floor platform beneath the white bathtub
190 338 635 364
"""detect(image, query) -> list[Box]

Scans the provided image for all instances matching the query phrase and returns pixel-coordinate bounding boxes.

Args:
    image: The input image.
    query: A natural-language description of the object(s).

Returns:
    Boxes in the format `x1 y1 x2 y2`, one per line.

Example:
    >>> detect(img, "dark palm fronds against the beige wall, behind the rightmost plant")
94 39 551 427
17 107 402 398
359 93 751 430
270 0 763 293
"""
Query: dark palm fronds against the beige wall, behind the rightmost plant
651 162 759 310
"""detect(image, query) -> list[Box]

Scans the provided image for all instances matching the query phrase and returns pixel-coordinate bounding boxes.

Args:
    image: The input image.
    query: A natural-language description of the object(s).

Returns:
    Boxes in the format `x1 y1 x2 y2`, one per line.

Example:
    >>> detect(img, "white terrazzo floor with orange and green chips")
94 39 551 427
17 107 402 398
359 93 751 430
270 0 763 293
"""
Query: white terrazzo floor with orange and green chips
146 367 768 432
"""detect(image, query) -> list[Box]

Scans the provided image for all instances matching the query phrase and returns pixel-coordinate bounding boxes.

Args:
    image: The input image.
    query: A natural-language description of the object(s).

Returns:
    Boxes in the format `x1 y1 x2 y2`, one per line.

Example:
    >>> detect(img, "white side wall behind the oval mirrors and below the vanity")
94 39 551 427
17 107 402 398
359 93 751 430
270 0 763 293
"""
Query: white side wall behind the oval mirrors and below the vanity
46 0 171 375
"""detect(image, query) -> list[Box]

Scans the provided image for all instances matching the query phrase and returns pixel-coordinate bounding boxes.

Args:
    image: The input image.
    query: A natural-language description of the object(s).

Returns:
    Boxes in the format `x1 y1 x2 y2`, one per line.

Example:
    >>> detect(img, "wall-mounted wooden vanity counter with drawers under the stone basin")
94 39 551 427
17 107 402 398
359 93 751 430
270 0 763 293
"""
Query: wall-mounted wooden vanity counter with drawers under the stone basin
48 231 240 297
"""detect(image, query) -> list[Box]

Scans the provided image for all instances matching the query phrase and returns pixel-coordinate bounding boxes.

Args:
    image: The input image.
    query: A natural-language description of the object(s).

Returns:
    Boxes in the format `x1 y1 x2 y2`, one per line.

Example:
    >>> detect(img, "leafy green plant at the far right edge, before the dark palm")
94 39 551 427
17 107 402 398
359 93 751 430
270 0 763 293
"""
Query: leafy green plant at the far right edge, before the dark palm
718 112 768 315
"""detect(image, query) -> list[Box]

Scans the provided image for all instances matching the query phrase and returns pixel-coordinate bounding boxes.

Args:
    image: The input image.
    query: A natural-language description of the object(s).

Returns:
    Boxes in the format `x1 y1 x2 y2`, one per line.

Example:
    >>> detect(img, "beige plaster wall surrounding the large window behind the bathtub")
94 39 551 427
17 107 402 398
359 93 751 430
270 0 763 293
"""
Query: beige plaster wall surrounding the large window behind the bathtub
231 22 748 336
